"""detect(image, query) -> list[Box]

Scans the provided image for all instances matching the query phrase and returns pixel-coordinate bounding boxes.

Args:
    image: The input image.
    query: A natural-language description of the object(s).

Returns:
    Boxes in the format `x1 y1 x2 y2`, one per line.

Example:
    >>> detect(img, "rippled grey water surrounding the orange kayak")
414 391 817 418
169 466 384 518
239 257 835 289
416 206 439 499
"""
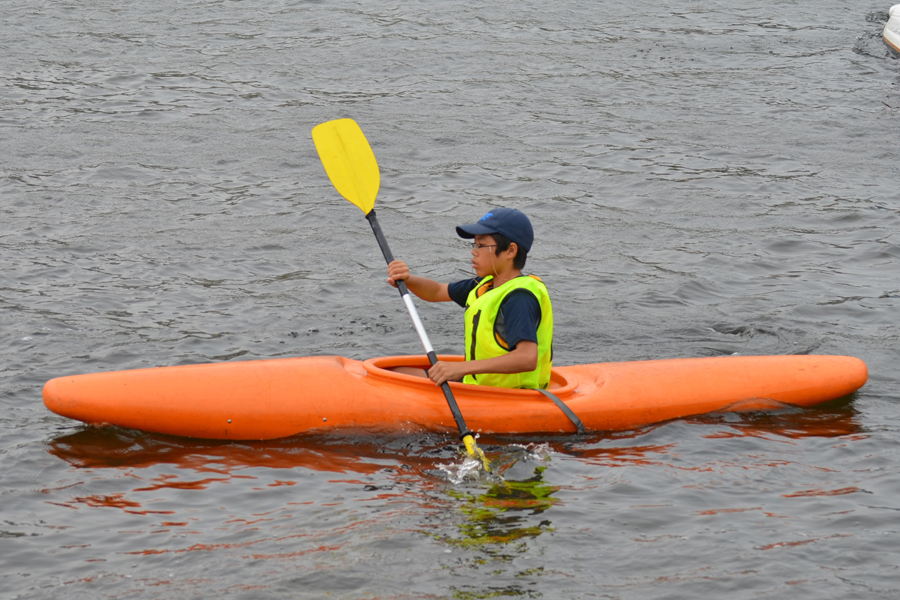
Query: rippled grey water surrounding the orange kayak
0 0 900 599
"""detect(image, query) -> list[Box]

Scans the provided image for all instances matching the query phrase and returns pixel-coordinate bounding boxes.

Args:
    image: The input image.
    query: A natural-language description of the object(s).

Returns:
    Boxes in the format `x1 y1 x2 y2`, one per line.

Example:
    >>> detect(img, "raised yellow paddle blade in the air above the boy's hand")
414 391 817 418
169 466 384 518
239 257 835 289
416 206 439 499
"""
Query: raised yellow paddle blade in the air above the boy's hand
313 119 381 214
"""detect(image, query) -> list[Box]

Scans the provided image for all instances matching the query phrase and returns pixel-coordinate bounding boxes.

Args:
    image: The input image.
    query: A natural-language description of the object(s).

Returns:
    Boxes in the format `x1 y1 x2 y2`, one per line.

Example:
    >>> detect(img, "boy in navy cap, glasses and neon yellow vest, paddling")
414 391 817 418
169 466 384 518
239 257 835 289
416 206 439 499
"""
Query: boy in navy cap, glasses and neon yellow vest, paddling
388 208 553 389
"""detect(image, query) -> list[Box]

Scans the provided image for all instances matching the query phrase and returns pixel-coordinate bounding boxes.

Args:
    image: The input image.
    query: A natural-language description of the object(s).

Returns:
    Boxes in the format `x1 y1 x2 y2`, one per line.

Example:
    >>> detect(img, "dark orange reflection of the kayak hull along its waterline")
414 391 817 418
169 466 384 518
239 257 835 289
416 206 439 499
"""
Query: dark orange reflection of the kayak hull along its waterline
48 399 862 478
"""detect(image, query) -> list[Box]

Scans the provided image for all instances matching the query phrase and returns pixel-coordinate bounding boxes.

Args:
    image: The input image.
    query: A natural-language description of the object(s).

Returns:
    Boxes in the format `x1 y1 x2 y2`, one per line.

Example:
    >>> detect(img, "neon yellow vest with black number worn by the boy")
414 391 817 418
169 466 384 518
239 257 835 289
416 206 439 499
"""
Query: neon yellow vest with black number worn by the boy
463 275 553 389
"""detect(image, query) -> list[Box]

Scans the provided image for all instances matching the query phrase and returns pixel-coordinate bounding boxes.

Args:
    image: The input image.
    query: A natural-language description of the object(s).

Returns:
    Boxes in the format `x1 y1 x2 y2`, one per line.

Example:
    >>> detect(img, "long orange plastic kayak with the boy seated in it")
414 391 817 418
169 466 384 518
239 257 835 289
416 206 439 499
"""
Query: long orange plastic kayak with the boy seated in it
44 356 868 440
